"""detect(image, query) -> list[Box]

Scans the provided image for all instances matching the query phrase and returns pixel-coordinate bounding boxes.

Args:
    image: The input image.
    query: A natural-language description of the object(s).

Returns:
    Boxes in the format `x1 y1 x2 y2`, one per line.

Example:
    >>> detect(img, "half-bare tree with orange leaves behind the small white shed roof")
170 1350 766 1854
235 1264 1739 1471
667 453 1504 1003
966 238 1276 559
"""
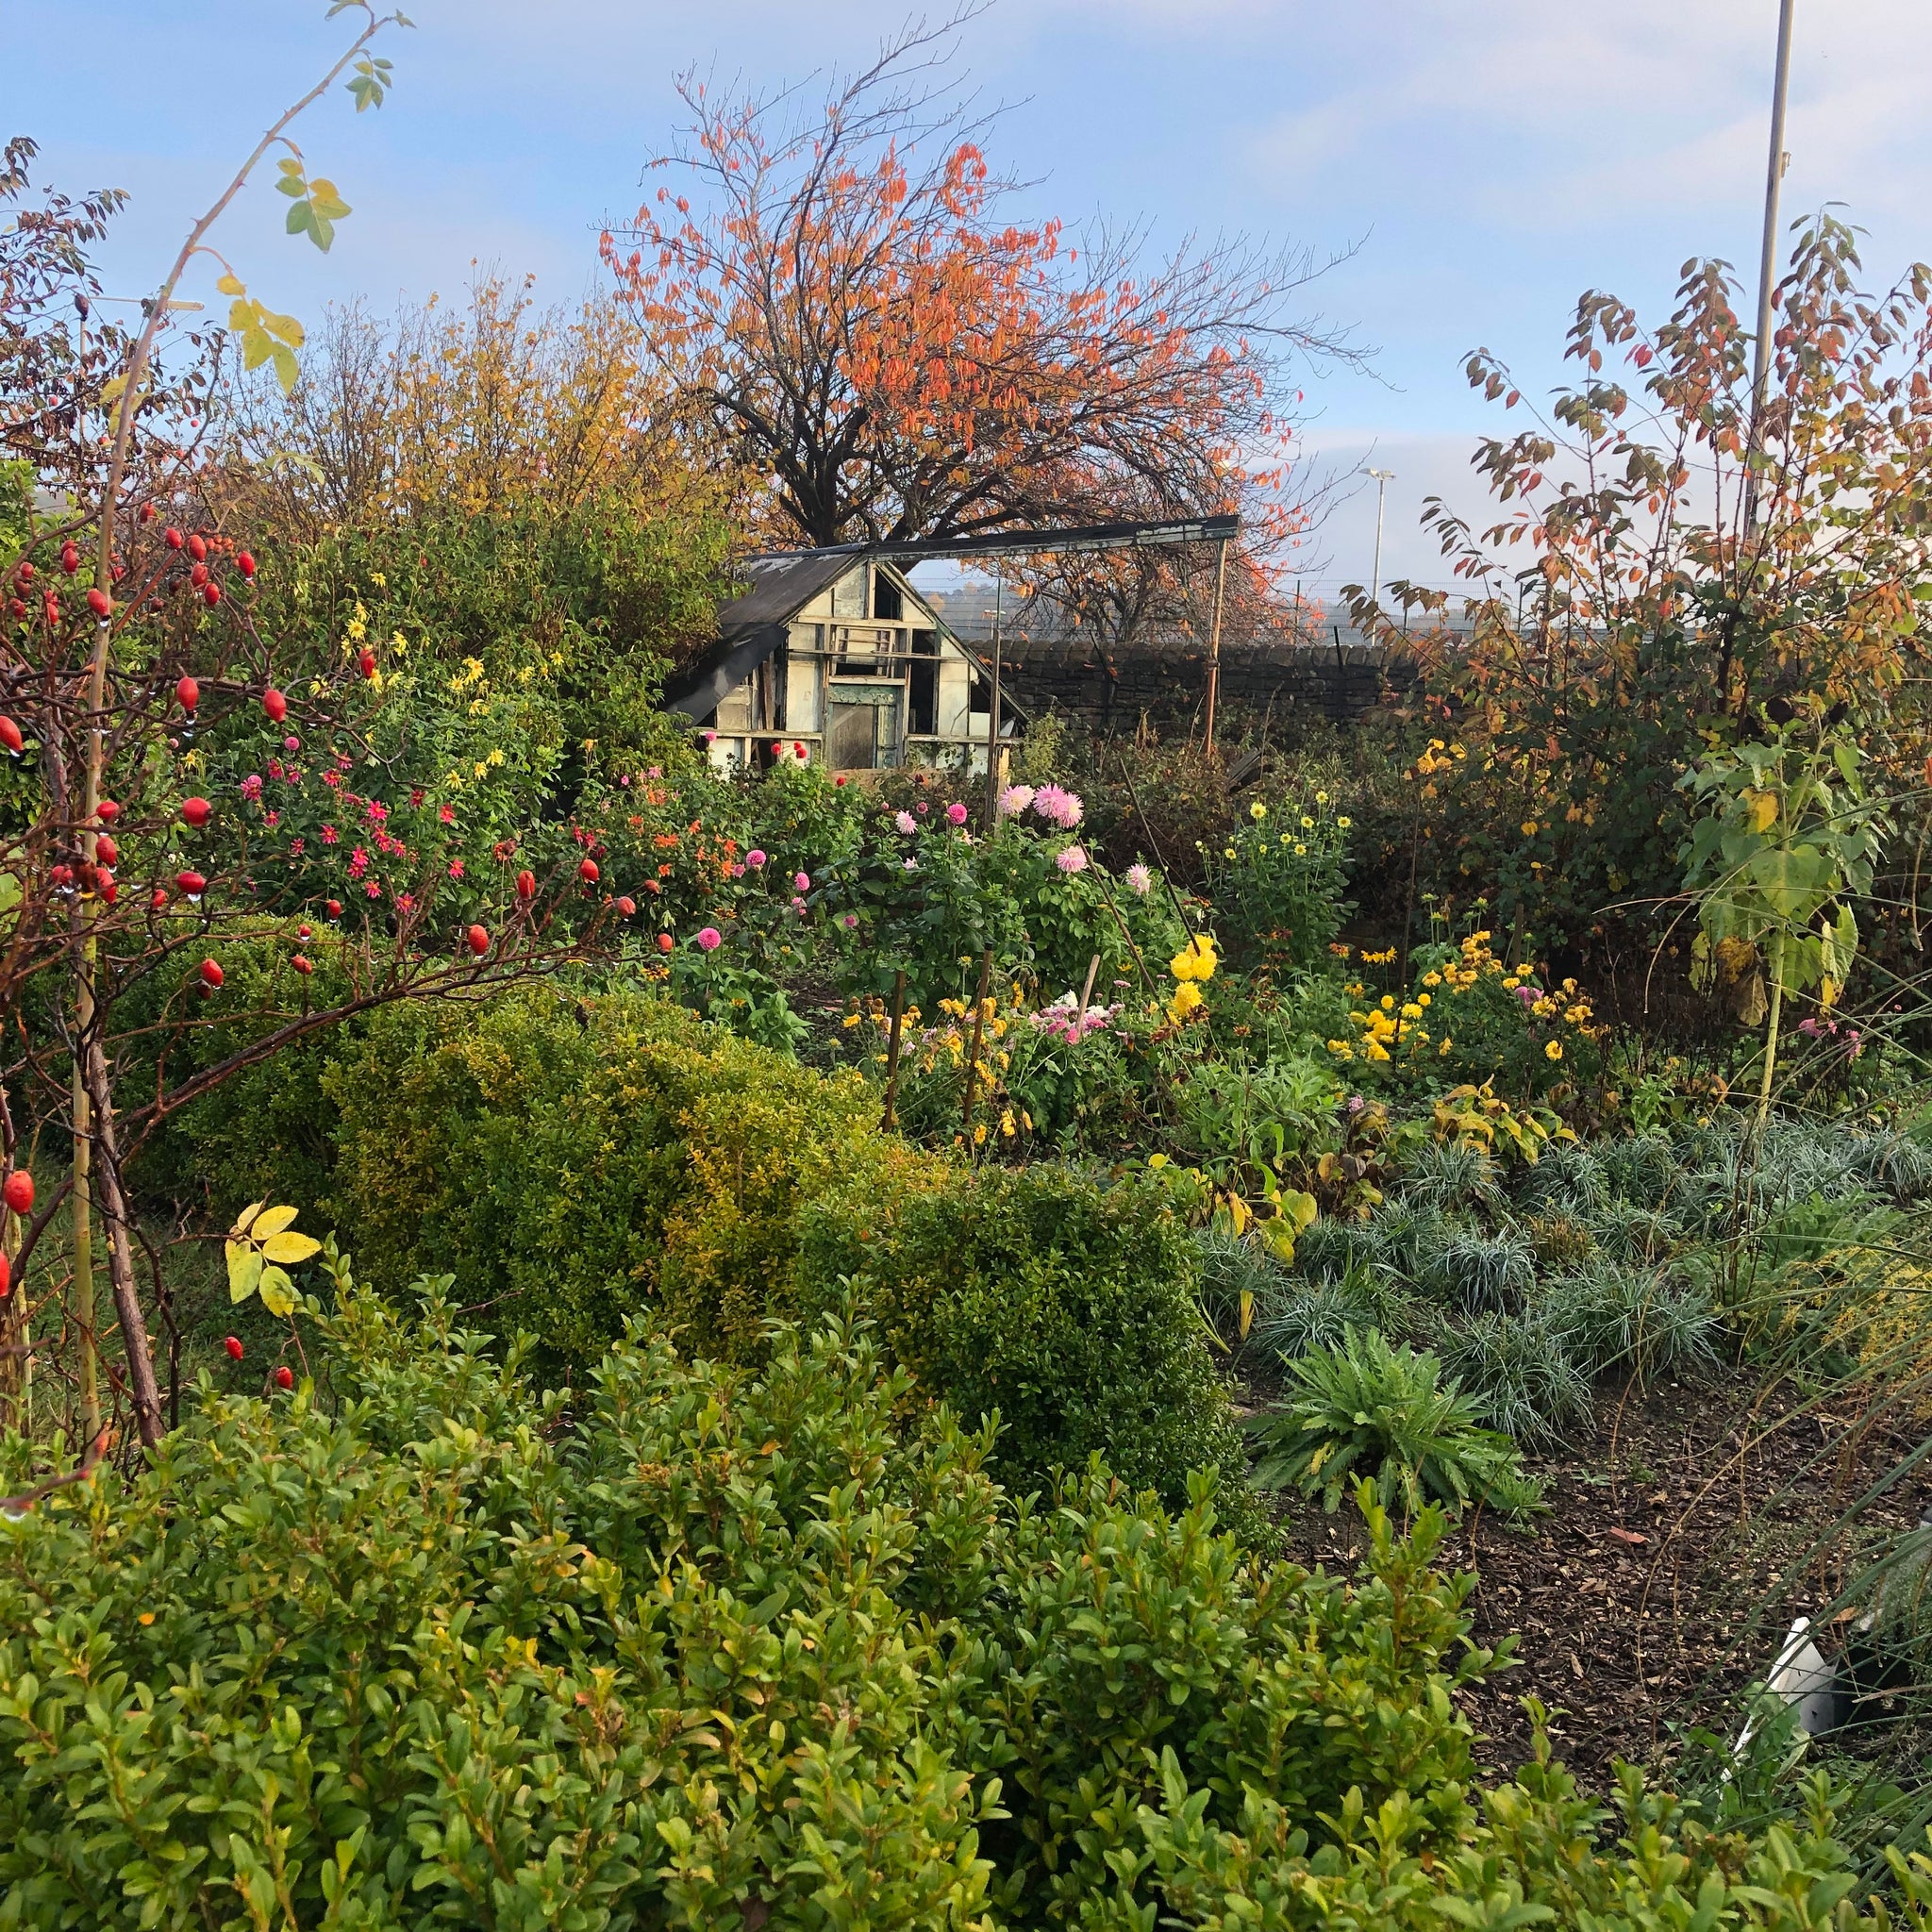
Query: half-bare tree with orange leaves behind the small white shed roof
603 6 1360 545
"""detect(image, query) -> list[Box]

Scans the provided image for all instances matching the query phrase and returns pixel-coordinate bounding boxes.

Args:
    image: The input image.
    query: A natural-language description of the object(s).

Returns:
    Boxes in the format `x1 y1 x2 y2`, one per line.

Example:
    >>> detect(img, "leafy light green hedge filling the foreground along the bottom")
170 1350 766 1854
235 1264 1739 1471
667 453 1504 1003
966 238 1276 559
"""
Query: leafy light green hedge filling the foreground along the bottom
0 1270 1908 1932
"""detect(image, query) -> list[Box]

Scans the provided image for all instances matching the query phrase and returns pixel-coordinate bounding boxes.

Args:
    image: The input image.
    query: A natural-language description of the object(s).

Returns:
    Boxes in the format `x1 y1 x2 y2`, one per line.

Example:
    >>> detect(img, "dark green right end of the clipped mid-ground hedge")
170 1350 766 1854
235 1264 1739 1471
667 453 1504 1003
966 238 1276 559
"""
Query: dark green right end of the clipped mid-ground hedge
800 1163 1257 1530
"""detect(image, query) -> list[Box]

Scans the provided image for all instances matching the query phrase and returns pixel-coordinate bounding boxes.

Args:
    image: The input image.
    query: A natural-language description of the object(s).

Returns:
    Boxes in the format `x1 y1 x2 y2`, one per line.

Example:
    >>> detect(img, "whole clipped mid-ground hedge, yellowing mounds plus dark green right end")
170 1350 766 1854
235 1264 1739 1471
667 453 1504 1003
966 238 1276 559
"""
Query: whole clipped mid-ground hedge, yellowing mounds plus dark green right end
323 991 1265 1536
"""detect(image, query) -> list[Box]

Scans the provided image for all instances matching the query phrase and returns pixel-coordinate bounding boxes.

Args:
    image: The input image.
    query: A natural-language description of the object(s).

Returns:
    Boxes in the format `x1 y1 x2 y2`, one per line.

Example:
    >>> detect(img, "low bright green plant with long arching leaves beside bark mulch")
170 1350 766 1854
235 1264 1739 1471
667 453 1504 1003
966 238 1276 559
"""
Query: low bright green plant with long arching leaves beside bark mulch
1254 1329 1541 1517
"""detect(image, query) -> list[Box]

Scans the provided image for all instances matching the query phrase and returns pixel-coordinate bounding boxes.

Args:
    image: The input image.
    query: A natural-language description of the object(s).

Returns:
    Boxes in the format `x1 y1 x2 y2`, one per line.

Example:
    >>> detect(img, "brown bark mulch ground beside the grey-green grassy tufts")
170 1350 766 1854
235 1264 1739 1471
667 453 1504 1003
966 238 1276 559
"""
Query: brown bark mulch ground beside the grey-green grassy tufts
1242 1381 1923 1790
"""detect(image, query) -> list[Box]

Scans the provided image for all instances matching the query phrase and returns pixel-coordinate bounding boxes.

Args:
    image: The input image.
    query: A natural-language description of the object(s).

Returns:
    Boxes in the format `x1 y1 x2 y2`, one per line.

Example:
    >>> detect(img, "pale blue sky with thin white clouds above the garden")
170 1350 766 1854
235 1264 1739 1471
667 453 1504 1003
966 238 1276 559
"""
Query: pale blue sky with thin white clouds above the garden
15 0 1932 593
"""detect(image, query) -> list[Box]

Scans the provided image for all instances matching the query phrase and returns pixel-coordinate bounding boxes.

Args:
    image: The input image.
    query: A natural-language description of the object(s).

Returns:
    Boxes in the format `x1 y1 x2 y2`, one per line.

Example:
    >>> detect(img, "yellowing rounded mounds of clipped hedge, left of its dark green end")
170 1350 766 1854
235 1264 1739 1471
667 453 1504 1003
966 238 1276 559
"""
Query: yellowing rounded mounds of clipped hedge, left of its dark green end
325 990 939 1372
